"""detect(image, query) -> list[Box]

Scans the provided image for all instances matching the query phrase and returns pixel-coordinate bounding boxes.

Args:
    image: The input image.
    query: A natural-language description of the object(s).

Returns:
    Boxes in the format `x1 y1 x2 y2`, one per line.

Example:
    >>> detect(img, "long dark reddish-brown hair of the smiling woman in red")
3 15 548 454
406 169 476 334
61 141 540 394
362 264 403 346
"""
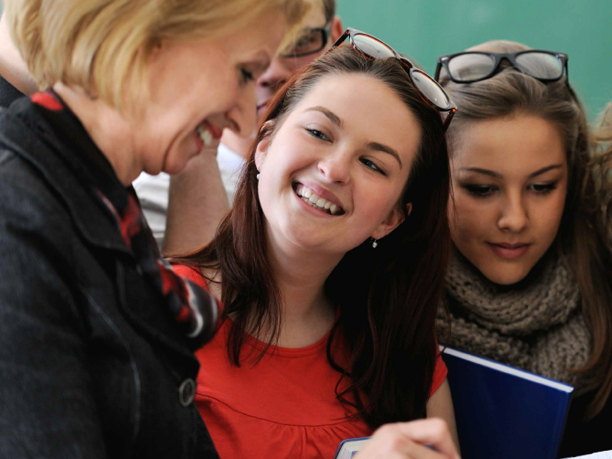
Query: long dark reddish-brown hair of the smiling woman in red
175 46 451 427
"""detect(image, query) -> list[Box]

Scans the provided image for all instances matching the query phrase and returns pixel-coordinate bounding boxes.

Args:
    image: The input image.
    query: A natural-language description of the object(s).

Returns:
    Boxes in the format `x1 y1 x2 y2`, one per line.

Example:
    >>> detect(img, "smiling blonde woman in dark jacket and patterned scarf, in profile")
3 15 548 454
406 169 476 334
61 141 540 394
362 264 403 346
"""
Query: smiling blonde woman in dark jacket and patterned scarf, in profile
0 0 306 459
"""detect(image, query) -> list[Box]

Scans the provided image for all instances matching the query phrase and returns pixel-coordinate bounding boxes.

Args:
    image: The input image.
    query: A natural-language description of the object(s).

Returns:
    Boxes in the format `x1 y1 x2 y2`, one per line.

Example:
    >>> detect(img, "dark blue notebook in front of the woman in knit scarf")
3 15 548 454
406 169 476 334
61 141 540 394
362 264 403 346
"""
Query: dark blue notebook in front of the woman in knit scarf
440 346 574 459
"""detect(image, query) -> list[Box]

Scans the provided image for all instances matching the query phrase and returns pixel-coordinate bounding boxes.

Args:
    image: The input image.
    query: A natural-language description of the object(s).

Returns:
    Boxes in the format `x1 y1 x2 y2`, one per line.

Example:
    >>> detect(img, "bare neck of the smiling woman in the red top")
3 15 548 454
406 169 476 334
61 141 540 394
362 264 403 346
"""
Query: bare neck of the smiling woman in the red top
269 232 341 347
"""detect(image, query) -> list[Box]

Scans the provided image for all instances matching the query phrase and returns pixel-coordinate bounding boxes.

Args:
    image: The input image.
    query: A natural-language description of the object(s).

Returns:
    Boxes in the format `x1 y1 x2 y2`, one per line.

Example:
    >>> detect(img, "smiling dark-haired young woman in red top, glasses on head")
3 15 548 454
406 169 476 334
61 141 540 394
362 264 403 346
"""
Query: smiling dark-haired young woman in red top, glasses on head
173 34 457 458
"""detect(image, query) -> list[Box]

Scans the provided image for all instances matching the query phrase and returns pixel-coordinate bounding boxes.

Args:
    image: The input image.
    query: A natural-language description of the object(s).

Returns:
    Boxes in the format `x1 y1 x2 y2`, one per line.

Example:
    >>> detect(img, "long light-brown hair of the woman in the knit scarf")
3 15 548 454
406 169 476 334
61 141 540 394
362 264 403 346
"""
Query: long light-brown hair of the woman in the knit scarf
441 40 612 418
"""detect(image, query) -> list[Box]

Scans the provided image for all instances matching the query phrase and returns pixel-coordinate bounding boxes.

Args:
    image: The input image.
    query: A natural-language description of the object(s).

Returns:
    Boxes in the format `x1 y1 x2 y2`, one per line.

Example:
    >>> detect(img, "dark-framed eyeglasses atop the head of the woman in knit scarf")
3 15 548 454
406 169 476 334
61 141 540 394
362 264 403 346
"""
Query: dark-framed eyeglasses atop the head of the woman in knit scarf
435 49 568 83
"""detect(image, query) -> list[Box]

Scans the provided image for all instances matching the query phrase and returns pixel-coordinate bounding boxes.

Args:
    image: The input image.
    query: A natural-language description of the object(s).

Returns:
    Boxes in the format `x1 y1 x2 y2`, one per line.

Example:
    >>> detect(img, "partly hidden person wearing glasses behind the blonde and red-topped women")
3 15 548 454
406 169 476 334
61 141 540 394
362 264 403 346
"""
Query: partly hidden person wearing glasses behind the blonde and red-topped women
134 0 344 253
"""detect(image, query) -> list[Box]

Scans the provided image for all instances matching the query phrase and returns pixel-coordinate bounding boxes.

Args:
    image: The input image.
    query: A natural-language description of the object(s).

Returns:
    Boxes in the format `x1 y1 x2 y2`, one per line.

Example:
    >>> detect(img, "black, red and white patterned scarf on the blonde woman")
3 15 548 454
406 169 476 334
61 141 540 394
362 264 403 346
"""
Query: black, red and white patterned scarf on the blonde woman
32 90 218 350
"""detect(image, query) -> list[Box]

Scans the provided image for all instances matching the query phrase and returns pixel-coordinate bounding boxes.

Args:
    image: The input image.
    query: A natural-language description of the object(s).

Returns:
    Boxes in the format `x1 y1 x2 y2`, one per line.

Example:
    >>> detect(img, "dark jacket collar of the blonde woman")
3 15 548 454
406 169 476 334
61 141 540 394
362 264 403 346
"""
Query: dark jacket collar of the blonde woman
0 93 130 253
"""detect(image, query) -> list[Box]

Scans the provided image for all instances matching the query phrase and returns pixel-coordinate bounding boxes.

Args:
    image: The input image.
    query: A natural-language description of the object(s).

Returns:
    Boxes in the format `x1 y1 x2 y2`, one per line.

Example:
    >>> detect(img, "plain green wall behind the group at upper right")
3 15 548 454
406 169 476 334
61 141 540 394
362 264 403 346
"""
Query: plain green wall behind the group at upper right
337 0 612 119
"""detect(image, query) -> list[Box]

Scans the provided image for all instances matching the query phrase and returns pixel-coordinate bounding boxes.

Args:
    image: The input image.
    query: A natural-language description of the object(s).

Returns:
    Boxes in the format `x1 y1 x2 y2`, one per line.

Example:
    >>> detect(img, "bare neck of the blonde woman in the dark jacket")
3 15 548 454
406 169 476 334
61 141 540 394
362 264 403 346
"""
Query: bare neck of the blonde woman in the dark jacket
53 83 142 186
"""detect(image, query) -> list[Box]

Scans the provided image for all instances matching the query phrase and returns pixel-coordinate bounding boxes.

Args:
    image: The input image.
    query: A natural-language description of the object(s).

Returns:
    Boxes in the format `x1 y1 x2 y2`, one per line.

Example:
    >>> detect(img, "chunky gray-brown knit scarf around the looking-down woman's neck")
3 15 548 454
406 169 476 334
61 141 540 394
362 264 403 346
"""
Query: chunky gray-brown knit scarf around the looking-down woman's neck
436 254 591 395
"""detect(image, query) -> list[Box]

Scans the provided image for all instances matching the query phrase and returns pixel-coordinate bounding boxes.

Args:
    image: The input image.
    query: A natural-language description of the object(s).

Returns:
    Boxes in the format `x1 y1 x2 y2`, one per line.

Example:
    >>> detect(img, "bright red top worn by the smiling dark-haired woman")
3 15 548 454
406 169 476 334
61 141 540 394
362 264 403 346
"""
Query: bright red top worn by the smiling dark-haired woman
174 266 447 459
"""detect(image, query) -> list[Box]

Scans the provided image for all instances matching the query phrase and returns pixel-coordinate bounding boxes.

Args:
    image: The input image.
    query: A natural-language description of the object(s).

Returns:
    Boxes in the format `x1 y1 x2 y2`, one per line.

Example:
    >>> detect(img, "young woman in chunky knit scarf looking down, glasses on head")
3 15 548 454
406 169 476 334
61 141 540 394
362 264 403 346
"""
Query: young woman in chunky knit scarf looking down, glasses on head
436 41 612 457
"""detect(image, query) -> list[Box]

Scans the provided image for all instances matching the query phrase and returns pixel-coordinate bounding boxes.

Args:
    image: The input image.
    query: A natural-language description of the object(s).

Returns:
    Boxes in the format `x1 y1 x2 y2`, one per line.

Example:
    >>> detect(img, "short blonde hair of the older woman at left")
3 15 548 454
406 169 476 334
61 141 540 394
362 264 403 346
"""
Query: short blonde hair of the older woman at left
4 0 310 109
